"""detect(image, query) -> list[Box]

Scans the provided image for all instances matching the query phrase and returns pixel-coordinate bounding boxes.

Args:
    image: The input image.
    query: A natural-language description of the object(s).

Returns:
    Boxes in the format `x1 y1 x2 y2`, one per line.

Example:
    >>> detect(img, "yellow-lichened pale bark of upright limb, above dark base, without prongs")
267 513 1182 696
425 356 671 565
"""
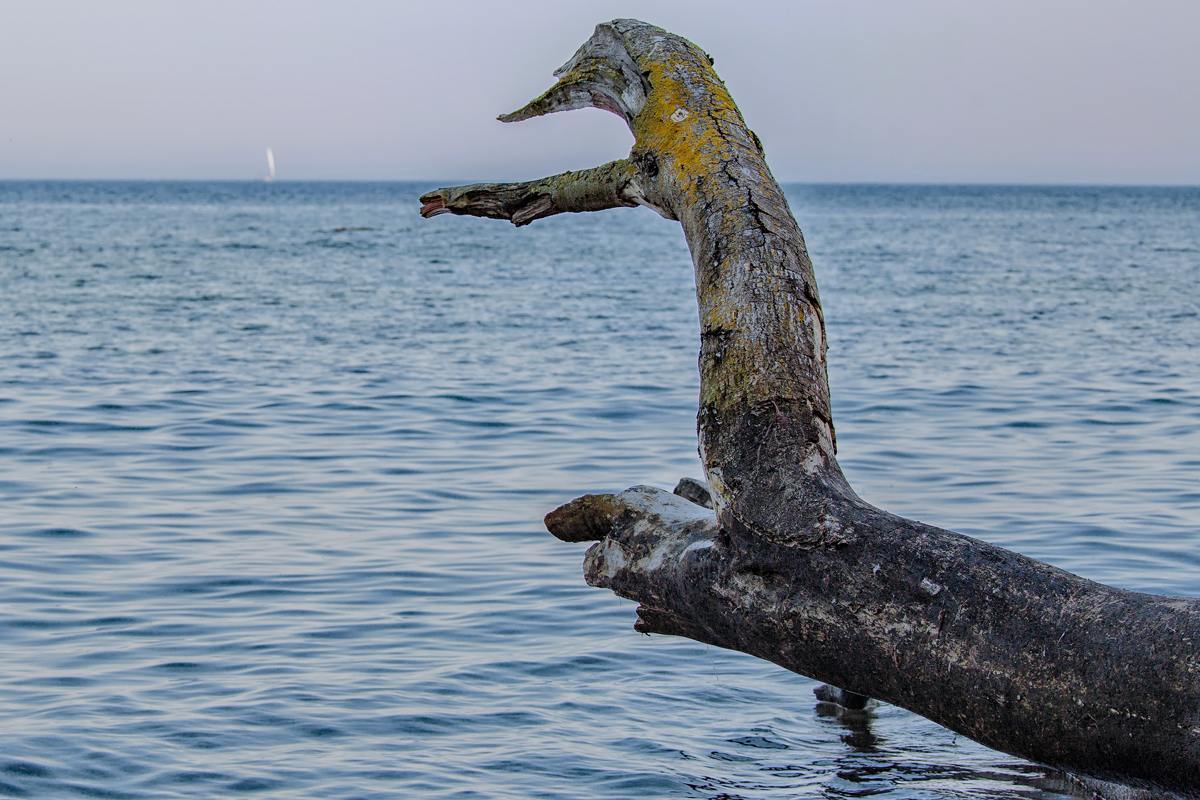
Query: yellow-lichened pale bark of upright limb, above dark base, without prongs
600 20 829 422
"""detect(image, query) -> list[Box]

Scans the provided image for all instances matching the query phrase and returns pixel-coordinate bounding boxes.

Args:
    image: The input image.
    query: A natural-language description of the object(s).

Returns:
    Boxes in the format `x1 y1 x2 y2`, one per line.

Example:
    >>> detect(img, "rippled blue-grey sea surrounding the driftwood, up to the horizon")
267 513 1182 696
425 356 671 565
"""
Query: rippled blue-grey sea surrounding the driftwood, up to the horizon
0 182 1200 800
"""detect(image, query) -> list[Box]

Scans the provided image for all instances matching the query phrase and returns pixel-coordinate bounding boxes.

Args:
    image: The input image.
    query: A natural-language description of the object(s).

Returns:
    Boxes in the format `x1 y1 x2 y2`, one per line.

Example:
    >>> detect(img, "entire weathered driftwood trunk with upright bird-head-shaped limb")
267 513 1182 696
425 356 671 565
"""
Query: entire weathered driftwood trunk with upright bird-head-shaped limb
421 19 1200 798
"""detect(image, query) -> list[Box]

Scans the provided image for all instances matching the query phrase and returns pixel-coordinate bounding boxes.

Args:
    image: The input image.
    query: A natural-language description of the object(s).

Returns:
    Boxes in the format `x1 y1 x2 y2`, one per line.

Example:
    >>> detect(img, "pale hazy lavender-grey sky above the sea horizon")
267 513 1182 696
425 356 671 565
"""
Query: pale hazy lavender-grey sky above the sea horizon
0 0 1200 184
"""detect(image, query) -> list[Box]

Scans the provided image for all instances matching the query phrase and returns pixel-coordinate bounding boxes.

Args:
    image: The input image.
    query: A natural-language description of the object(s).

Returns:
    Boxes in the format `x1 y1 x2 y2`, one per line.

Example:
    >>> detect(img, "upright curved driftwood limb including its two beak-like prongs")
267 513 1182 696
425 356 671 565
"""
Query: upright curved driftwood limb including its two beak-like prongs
421 19 857 527
